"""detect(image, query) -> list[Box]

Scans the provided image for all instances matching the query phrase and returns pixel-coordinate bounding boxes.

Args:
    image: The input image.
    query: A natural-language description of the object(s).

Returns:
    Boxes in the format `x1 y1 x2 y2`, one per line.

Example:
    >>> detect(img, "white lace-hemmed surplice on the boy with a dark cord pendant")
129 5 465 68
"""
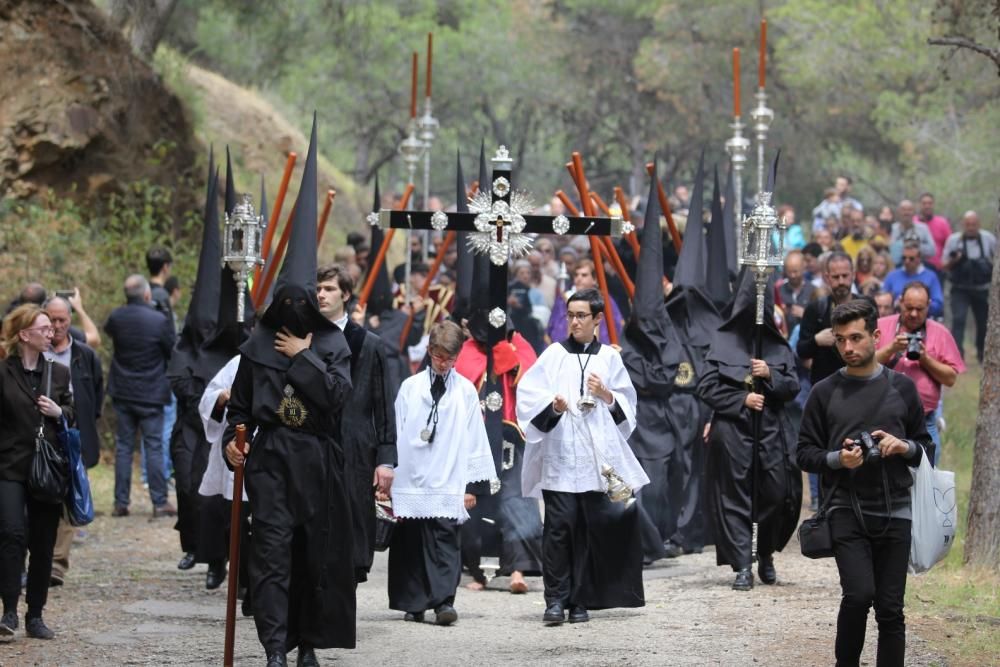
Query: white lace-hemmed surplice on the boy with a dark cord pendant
392 370 497 522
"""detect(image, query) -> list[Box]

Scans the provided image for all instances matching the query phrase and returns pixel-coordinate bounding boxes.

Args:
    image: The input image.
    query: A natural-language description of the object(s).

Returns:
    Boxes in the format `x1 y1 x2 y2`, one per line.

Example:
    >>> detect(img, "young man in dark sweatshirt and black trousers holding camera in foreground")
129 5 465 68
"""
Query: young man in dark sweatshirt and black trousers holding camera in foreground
796 299 930 667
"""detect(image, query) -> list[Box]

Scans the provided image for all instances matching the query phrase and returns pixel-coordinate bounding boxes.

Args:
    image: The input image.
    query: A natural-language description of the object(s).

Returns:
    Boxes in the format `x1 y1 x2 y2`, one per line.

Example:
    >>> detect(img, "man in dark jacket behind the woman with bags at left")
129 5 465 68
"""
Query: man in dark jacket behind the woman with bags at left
45 296 104 586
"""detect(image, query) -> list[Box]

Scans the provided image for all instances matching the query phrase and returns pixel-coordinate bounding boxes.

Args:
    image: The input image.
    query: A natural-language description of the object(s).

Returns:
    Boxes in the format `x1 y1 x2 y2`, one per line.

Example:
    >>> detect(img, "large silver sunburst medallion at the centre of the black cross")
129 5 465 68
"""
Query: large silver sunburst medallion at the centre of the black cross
468 188 534 266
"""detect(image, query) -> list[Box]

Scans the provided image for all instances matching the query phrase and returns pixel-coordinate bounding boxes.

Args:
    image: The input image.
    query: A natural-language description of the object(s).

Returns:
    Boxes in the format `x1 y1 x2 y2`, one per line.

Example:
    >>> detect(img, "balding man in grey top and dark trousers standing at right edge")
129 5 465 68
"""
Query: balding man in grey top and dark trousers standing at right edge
942 211 997 364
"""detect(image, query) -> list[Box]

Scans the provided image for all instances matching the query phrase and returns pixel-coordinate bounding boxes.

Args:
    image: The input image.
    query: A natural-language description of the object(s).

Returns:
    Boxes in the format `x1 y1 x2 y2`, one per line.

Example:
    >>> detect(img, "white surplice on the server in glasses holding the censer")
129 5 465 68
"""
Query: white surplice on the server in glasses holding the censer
517 343 649 498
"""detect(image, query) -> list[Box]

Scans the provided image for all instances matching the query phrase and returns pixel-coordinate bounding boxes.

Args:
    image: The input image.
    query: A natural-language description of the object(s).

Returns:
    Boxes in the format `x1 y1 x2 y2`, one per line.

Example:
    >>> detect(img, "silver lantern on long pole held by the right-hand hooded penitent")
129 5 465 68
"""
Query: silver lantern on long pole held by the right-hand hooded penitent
739 191 787 562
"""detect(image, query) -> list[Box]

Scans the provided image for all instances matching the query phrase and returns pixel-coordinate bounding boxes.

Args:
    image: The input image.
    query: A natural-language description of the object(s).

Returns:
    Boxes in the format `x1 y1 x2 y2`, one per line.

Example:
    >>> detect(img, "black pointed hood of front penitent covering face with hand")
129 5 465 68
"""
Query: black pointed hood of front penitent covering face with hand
241 113 347 370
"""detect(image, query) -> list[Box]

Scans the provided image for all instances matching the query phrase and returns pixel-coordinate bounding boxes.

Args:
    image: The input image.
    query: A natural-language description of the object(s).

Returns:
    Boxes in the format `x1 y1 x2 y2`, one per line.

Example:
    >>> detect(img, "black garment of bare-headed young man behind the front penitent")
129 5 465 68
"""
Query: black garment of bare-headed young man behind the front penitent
340 320 397 581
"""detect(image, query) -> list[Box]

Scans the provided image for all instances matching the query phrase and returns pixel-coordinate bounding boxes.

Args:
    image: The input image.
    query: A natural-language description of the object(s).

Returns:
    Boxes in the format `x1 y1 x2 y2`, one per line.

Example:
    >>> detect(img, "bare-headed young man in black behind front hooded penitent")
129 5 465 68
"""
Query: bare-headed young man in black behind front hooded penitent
316 264 397 582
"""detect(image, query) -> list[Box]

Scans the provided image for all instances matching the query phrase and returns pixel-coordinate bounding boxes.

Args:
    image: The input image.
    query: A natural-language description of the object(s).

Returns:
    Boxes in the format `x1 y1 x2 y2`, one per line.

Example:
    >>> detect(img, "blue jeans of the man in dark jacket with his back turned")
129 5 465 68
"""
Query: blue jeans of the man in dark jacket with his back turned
111 400 167 507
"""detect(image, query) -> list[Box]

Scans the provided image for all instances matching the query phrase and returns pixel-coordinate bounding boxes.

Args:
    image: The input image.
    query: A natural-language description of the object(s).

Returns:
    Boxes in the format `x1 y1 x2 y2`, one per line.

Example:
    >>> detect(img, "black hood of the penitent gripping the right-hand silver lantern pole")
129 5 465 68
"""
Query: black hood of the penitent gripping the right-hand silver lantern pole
707 268 795 382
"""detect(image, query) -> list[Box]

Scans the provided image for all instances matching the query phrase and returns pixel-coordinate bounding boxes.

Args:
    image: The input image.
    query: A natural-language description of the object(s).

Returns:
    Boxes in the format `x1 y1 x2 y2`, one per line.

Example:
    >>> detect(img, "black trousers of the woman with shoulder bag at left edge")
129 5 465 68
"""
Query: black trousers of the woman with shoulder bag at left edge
0 480 63 617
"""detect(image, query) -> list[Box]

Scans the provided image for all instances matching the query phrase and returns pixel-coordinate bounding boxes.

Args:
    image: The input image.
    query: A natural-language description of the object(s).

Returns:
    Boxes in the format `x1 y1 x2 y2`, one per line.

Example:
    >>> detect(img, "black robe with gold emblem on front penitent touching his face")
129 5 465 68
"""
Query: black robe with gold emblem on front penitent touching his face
224 332 356 652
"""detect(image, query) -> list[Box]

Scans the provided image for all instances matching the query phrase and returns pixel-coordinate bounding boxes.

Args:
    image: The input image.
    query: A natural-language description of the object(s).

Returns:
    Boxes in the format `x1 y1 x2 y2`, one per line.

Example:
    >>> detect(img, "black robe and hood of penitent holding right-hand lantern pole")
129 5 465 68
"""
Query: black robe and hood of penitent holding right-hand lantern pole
698 274 802 570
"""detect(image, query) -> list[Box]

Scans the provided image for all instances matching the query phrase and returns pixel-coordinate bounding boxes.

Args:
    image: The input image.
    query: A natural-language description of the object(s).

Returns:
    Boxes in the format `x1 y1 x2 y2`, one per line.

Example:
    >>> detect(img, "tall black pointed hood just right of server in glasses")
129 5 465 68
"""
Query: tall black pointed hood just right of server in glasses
621 165 687 395
